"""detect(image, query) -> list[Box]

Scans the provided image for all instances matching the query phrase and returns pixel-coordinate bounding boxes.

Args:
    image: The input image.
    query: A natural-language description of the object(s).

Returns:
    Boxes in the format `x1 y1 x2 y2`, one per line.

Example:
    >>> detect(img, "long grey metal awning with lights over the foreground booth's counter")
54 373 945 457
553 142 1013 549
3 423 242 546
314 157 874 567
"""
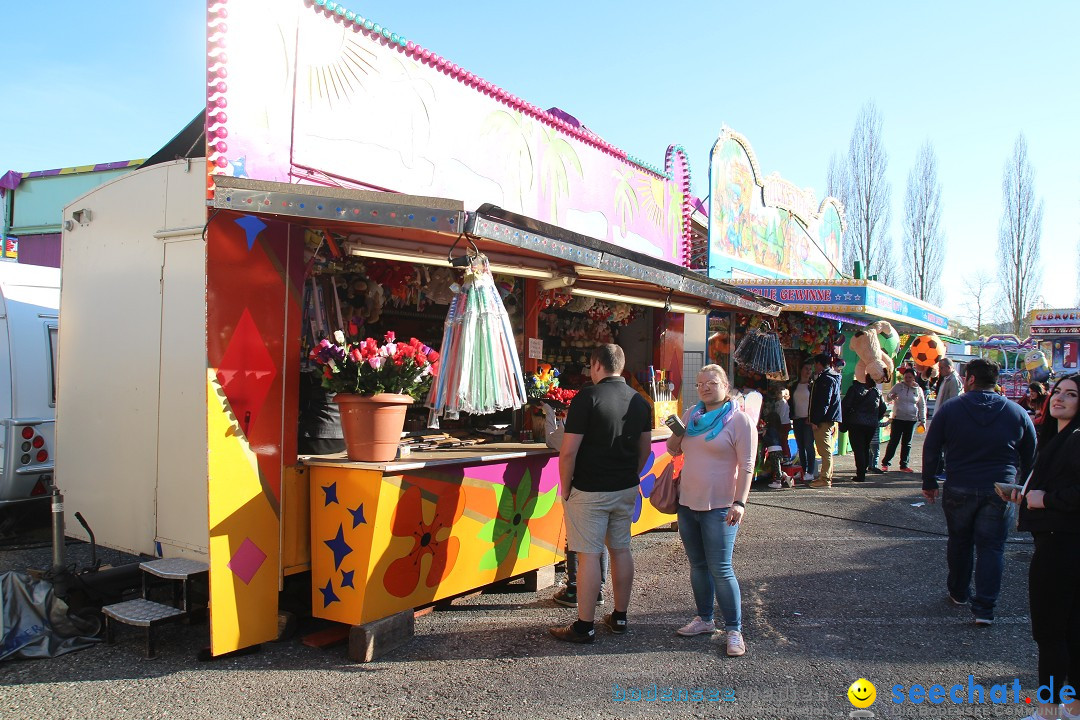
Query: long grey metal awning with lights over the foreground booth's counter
212 176 783 315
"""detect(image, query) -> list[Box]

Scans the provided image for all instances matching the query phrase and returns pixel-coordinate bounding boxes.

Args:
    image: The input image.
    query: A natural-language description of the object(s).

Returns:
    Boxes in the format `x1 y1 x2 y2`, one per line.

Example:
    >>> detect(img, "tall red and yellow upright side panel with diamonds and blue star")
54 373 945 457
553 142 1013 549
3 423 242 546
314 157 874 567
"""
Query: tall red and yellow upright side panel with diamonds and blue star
206 212 303 654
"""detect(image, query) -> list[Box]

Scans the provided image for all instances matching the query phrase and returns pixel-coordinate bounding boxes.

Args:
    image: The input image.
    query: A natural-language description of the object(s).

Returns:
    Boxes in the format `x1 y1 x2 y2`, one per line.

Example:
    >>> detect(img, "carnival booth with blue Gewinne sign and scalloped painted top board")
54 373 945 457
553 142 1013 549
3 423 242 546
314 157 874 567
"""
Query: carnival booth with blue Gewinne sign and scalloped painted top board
708 127 948 472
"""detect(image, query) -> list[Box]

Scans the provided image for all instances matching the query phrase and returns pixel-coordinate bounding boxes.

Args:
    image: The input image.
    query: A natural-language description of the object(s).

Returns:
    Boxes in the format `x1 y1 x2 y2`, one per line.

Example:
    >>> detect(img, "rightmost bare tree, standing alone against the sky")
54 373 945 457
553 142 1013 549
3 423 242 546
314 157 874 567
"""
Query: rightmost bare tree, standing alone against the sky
998 133 1042 336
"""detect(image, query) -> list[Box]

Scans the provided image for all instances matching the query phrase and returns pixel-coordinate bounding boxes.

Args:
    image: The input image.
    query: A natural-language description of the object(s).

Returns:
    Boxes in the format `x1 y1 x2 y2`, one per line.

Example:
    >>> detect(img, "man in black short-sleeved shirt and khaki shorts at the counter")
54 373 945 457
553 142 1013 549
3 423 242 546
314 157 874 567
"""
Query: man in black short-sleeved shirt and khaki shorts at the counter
550 344 652 642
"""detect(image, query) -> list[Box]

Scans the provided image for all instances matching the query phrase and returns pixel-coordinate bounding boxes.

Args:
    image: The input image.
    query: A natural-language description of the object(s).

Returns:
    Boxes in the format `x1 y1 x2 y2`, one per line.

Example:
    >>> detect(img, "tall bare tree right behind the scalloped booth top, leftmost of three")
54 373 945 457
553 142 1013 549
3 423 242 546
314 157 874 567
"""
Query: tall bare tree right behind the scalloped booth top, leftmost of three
843 101 892 283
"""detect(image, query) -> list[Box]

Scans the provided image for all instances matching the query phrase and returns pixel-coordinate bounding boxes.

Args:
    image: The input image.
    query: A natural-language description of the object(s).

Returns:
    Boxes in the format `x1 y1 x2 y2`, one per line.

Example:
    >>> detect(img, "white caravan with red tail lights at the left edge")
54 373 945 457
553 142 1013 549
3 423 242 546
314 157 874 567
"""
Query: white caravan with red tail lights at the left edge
0 261 60 510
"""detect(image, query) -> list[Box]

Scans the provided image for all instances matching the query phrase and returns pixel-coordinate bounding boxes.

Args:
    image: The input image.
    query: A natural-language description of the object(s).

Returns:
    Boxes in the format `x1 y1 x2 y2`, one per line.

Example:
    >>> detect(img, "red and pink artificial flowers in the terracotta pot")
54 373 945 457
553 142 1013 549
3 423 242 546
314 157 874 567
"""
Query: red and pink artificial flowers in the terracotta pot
310 330 438 400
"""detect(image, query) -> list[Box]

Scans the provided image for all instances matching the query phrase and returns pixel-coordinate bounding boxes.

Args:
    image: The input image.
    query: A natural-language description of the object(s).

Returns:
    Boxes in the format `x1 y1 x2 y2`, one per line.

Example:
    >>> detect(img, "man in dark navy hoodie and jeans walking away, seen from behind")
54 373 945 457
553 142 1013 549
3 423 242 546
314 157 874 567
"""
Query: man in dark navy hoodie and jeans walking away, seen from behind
922 359 1035 625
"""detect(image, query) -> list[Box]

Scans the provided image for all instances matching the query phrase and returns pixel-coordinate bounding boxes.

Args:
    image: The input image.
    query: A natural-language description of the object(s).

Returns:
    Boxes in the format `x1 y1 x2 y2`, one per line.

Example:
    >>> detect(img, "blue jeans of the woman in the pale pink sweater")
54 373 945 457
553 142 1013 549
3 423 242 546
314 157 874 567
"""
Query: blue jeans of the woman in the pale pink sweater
678 505 742 631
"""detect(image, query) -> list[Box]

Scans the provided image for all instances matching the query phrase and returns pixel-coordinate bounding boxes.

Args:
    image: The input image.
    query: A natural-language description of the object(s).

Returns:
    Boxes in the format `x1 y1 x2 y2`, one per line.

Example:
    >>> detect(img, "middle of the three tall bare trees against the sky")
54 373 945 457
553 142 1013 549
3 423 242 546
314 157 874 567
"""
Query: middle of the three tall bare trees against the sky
901 140 945 303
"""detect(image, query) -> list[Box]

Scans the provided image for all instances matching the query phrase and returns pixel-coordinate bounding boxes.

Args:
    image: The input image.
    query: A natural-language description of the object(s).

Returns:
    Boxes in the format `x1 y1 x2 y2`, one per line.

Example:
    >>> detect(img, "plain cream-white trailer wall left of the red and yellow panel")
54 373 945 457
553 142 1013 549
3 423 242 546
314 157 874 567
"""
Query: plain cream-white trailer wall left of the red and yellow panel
56 160 210 560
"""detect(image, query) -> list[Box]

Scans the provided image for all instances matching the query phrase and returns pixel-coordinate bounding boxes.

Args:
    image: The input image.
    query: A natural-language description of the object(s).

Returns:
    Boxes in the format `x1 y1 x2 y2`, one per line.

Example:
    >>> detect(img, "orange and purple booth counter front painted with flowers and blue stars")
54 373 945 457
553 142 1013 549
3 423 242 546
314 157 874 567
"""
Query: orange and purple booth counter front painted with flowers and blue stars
311 443 673 624
